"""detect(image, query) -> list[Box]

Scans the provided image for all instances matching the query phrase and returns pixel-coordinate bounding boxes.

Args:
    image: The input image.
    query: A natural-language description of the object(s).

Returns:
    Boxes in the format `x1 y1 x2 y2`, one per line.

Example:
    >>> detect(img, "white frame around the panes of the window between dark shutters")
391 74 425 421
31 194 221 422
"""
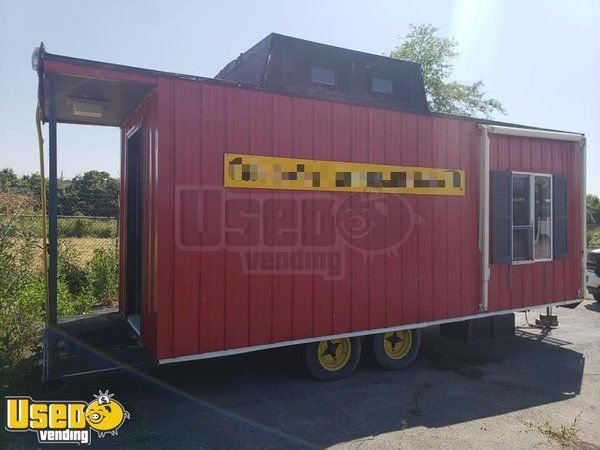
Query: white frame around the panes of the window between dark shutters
510 171 554 266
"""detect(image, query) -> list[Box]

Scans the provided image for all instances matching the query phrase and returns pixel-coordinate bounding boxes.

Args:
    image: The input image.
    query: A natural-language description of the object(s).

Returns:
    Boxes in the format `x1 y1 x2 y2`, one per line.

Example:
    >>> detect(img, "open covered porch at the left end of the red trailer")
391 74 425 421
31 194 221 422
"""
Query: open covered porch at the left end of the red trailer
34 48 157 381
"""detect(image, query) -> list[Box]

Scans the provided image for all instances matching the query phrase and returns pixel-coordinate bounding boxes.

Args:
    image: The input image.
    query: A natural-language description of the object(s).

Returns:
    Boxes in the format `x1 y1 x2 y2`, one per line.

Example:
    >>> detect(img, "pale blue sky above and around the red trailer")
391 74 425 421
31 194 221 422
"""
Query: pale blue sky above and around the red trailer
0 0 600 195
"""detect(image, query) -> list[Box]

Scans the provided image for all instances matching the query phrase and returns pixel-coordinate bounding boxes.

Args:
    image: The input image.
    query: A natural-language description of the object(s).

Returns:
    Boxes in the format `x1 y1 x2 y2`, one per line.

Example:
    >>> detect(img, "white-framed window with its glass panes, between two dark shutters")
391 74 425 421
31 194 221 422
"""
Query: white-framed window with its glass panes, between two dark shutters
512 172 552 263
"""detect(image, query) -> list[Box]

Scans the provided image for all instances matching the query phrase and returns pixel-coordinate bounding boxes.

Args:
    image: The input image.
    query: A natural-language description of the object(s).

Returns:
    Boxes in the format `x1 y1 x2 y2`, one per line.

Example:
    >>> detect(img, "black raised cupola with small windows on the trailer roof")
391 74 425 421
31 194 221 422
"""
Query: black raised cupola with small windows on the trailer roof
215 33 429 114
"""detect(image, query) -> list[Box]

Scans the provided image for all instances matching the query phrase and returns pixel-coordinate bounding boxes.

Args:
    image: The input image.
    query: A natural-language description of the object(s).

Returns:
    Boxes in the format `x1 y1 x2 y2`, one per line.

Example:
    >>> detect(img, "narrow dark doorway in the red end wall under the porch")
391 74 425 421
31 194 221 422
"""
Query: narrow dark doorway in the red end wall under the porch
125 126 144 334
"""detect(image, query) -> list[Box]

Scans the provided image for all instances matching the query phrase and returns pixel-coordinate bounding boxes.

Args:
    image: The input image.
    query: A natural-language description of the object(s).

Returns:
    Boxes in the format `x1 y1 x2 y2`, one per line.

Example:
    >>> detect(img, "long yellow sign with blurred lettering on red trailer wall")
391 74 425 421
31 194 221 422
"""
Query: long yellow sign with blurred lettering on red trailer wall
224 153 465 195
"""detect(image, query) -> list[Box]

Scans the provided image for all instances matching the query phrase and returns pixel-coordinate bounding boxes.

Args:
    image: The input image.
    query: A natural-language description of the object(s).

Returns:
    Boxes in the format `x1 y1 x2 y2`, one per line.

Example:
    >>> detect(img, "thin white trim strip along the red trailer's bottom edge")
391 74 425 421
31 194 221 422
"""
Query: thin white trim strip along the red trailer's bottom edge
158 299 583 364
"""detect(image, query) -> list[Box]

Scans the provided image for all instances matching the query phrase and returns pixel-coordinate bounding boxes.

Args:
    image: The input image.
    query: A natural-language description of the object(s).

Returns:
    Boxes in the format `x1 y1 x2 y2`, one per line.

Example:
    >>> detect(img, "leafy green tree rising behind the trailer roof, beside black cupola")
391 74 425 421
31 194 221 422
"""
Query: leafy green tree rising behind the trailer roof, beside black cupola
390 24 505 117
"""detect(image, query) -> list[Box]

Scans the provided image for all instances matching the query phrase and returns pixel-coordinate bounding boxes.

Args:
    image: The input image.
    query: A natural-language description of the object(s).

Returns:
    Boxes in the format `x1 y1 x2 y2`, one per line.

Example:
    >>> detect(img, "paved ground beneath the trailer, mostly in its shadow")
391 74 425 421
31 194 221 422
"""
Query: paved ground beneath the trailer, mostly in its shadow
2 301 600 449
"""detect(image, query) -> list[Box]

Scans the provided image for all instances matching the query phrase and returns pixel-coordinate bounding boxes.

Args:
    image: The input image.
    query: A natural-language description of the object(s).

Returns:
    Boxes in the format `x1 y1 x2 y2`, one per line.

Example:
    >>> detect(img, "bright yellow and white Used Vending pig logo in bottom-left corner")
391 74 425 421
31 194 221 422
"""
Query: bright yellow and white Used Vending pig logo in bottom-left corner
6 391 130 444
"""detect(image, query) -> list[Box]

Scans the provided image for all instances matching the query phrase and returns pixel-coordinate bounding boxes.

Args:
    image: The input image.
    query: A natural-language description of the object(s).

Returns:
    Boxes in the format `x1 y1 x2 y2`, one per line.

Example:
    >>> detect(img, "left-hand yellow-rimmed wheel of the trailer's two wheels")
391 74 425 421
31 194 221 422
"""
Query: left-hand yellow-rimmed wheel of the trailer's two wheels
305 337 361 381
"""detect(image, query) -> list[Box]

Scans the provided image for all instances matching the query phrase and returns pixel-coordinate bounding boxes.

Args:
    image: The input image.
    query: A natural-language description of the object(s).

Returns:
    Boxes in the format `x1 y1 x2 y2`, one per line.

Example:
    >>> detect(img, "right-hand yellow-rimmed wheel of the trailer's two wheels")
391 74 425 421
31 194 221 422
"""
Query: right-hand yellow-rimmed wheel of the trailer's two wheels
371 330 421 370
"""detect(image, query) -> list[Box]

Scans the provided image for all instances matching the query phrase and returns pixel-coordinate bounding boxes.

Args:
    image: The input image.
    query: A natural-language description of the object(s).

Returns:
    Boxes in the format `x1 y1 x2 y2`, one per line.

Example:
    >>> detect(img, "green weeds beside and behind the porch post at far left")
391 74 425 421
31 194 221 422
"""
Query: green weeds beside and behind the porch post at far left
0 193 118 395
